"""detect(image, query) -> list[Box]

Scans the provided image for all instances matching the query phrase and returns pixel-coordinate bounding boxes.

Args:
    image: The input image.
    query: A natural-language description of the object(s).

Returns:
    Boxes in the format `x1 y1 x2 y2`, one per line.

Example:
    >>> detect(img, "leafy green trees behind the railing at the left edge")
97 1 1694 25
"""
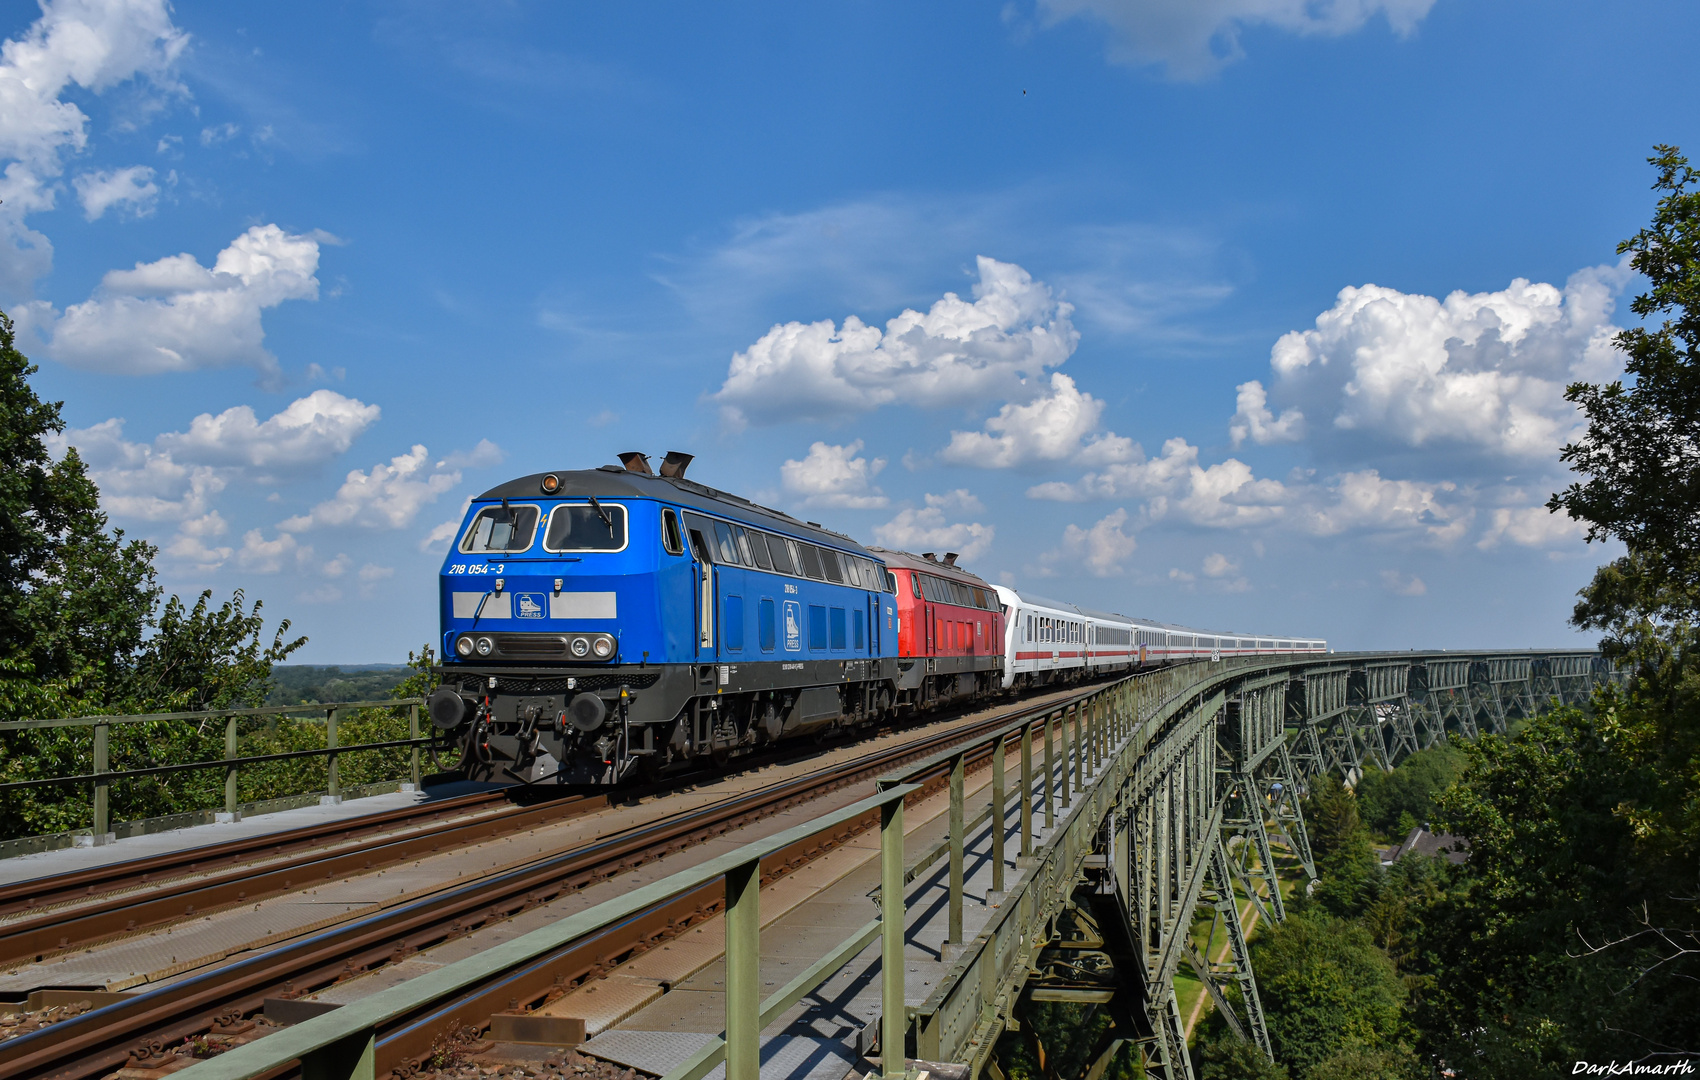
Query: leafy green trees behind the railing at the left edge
0 313 306 837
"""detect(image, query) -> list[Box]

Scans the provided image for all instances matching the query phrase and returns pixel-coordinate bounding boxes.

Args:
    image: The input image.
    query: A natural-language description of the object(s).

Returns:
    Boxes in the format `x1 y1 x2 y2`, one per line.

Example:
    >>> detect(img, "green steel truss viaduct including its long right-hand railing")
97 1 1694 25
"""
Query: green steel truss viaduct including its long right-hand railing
162 651 1618 1080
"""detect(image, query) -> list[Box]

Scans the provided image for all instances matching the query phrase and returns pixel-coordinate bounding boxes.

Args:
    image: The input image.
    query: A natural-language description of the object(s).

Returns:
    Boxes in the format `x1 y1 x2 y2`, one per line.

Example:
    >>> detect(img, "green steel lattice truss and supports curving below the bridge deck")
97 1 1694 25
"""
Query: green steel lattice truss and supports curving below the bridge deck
915 651 1620 1080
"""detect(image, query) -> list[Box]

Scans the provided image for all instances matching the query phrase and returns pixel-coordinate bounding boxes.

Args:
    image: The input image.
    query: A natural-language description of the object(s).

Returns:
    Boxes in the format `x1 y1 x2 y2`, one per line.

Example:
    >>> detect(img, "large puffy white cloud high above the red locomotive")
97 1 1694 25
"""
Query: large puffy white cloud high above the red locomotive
714 255 1080 425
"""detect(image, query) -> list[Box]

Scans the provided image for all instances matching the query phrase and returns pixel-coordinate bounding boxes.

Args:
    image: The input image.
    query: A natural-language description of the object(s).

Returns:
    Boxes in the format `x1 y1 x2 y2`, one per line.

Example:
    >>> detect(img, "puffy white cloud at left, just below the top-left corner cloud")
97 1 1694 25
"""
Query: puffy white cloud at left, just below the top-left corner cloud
36 225 320 379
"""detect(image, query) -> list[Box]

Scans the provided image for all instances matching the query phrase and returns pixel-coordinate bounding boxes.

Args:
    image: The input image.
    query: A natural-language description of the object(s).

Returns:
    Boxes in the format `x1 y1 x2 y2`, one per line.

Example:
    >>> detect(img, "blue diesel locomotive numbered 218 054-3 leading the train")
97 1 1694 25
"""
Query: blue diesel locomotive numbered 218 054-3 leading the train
428 452 899 784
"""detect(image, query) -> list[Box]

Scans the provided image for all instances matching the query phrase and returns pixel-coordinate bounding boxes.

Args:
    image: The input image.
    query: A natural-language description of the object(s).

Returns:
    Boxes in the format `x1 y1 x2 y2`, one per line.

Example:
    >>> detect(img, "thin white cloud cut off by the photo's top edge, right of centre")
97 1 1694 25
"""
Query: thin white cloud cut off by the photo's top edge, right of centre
1039 0 1435 80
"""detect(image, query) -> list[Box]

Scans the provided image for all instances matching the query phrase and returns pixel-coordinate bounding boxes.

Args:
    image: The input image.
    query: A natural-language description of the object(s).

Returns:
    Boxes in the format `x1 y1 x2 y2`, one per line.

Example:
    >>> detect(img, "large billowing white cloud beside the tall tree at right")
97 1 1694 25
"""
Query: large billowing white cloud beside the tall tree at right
1271 264 1630 463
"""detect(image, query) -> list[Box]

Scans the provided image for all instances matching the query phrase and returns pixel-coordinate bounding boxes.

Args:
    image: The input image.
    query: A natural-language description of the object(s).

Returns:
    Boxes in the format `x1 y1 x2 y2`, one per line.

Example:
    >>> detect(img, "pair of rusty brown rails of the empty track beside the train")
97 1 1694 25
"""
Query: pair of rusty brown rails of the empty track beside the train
0 692 1085 1080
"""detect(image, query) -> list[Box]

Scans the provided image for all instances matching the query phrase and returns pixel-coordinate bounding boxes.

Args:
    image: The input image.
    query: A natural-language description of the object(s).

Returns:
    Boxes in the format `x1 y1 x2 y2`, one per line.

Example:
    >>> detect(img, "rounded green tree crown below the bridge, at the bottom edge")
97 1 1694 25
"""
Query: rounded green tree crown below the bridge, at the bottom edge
1251 908 1408 1078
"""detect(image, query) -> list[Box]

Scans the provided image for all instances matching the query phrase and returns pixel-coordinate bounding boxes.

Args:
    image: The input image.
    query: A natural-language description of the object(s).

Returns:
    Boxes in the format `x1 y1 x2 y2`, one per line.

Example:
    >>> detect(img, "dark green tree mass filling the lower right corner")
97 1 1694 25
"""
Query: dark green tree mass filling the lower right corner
1418 700 1700 1077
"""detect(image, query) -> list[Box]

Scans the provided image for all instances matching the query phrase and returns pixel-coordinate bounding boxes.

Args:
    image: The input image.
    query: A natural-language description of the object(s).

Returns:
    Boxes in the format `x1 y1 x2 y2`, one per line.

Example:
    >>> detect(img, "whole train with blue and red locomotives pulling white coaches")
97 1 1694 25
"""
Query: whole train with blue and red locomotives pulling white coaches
428 452 1328 786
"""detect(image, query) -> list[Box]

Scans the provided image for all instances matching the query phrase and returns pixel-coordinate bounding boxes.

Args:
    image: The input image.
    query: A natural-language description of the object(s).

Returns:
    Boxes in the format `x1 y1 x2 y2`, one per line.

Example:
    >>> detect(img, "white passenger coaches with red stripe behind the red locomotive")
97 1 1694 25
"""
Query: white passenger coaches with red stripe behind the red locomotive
995 585 1328 687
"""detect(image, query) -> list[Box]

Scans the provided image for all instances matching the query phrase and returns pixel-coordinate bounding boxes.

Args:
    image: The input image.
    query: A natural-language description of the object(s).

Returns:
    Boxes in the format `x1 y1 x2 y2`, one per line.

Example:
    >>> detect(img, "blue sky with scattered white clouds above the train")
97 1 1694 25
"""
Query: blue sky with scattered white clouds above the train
0 0 1700 663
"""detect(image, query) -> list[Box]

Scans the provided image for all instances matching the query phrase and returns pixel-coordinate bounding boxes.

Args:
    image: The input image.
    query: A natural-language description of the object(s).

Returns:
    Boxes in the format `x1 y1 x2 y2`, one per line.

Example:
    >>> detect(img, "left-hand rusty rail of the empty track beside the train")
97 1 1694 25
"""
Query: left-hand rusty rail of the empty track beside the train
0 687 1097 1080
